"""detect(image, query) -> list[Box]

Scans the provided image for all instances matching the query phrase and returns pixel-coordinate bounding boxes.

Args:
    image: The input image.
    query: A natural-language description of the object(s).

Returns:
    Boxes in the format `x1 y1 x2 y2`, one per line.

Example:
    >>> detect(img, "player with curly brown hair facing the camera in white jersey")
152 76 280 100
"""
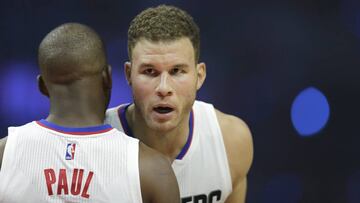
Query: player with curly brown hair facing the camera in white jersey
106 5 253 203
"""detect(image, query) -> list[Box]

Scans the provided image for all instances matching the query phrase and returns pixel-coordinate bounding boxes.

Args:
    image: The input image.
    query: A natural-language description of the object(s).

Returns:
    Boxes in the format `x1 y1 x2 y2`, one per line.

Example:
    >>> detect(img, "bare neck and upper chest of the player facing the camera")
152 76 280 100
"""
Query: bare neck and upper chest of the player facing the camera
126 104 190 160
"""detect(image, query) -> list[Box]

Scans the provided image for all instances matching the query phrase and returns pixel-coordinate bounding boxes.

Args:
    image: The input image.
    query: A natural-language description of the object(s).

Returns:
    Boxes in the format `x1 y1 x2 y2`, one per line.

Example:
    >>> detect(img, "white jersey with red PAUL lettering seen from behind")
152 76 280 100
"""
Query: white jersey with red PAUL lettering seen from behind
0 120 142 203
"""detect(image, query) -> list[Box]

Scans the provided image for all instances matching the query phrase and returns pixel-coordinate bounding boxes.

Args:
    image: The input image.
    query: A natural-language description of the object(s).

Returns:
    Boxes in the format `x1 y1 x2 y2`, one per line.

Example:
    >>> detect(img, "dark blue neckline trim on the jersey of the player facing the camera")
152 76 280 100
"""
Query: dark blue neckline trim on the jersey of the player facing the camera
118 104 194 159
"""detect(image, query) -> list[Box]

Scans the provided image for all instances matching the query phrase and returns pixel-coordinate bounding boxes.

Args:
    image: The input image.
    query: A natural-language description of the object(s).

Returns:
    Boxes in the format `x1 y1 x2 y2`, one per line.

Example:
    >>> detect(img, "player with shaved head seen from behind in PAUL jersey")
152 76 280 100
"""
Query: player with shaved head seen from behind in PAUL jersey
0 23 180 203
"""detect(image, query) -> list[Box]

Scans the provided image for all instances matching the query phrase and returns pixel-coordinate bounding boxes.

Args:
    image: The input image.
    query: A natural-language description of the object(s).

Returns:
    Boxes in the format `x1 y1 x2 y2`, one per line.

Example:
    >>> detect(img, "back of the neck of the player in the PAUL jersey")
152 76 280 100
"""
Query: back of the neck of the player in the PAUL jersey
46 84 105 127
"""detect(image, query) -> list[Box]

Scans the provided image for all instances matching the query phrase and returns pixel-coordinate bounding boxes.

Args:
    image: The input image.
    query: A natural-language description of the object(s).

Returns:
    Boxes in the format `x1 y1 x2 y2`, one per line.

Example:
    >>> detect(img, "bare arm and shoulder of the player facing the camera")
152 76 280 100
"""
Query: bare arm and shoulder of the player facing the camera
216 111 253 203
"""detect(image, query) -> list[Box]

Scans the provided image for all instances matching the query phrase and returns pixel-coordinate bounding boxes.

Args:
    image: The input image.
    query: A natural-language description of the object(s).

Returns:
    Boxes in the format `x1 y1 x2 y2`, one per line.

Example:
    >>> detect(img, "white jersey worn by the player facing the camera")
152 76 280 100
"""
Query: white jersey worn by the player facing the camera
105 101 232 203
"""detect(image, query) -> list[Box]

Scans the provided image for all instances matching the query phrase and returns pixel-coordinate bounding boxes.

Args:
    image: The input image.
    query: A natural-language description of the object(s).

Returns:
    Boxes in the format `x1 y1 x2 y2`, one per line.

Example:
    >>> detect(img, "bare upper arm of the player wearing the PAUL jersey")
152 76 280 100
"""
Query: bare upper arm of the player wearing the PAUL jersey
139 142 180 203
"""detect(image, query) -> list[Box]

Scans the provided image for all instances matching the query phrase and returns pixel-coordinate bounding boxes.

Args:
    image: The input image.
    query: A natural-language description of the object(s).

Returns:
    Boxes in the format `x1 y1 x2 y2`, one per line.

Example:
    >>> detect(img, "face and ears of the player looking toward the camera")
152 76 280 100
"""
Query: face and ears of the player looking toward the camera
125 38 206 131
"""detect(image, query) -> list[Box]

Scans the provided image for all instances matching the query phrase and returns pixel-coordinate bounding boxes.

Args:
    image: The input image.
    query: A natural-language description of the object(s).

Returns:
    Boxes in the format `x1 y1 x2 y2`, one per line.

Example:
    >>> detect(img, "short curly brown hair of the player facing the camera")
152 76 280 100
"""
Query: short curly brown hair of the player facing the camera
128 5 200 61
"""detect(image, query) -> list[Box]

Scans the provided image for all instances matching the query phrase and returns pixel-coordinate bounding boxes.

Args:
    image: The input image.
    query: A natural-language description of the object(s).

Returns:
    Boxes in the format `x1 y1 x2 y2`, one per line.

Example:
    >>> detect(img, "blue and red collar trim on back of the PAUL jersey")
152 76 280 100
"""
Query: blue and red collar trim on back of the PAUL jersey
38 119 112 134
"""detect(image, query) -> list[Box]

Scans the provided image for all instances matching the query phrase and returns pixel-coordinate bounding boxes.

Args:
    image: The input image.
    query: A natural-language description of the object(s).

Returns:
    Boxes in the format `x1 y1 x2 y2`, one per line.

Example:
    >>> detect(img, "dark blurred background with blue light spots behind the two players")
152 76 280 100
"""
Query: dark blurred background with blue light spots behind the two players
0 0 360 203
